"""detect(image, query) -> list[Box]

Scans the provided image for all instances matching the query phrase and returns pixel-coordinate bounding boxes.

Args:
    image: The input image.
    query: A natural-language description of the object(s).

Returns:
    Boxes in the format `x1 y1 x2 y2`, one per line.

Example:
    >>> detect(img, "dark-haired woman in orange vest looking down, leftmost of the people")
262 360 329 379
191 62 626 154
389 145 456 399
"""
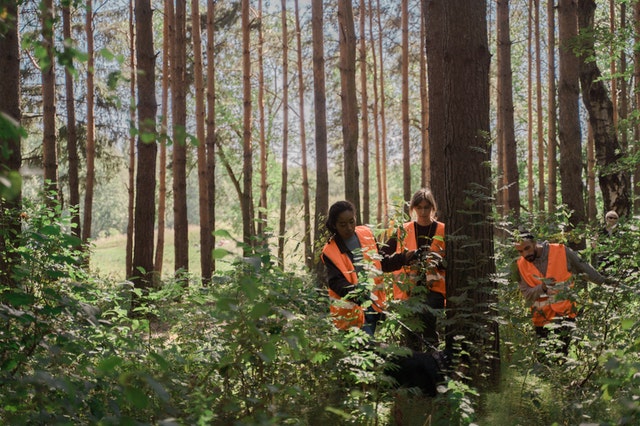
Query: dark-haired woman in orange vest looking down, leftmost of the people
321 201 414 336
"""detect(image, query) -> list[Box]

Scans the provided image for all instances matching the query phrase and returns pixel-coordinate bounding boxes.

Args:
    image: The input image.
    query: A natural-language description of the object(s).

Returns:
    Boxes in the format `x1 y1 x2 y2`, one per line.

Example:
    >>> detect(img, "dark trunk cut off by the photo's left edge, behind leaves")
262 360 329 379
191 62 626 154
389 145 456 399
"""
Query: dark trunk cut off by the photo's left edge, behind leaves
0 1 22 287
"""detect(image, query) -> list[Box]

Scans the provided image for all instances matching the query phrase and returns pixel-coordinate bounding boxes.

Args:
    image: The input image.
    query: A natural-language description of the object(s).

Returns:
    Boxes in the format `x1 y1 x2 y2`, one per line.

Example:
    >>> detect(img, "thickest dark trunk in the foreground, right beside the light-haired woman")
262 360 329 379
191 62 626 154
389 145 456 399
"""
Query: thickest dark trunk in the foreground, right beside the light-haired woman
422 0 499 379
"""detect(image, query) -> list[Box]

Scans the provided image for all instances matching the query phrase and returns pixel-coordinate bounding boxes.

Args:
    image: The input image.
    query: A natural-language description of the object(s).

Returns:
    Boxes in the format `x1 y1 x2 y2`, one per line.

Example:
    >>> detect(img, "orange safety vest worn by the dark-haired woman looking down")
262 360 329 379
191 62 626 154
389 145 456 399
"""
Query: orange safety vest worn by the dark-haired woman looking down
322 226 387 330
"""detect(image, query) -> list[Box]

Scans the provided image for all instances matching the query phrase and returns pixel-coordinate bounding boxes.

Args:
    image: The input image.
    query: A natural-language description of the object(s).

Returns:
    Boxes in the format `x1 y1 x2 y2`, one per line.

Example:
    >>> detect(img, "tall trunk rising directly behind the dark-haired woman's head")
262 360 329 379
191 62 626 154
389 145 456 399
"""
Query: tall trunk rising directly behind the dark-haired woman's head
338 0 362 223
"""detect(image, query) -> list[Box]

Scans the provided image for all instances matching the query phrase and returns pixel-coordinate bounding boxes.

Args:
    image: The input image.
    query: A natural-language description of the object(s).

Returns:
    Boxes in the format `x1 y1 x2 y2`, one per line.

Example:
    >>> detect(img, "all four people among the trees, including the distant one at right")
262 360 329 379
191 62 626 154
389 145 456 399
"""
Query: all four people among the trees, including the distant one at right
321 188 618 355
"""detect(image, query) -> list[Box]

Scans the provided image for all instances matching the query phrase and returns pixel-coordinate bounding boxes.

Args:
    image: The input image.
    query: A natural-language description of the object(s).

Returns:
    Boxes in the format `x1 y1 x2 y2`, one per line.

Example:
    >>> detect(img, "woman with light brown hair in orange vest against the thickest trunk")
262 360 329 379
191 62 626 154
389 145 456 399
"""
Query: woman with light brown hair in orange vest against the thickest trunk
382 188 447 350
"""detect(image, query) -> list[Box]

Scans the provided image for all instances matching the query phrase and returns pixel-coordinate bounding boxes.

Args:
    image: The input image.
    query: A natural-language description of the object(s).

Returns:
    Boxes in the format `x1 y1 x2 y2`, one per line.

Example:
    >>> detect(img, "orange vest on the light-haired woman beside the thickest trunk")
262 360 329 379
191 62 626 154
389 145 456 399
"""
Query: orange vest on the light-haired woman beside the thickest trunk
393 221 447 300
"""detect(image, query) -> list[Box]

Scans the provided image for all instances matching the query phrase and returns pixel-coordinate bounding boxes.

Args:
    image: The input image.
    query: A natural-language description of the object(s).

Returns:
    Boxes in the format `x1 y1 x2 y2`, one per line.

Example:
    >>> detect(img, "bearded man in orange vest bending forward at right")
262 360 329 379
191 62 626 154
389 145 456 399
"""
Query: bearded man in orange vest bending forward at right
515 231 613 355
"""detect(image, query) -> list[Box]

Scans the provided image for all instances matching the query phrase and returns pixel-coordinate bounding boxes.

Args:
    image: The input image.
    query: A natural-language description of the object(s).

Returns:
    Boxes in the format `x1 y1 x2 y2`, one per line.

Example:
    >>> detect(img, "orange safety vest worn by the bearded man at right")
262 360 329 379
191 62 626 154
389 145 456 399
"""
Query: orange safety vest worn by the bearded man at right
518 244 577 327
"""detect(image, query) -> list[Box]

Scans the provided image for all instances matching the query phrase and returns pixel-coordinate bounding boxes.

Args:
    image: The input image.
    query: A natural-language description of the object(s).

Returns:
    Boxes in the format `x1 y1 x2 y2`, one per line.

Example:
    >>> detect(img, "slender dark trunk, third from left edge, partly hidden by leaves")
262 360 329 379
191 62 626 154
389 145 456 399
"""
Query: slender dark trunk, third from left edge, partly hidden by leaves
61 5 82 243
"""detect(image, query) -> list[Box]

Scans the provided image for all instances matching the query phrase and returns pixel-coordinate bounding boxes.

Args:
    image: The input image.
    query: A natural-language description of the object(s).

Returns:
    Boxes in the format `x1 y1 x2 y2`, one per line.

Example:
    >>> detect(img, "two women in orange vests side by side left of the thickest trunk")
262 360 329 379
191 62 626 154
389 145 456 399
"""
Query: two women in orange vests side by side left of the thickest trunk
321 188 446 350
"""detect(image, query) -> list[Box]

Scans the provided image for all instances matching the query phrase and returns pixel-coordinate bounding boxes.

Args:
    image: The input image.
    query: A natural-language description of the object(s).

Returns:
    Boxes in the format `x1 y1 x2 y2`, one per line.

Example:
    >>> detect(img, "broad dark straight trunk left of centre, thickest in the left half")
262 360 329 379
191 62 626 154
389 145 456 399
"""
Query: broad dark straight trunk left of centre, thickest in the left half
131 0 158 289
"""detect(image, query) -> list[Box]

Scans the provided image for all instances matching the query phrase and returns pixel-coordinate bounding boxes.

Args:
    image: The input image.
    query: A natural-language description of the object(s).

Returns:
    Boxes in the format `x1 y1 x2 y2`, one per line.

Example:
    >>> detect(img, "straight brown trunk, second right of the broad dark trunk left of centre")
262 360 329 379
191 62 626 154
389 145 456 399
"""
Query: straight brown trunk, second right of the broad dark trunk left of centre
171 0 189 273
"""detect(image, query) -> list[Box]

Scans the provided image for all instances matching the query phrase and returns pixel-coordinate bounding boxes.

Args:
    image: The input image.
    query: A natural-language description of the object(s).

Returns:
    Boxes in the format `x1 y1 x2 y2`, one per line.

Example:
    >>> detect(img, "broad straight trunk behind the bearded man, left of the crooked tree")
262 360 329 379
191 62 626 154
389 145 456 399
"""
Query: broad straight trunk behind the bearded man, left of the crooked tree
558 0 585 238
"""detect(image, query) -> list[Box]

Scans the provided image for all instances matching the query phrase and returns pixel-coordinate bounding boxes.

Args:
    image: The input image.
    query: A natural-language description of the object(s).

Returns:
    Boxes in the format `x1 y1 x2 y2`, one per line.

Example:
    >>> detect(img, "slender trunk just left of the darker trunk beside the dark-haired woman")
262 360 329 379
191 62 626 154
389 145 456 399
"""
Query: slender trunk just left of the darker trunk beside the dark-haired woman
294 0 313 269
